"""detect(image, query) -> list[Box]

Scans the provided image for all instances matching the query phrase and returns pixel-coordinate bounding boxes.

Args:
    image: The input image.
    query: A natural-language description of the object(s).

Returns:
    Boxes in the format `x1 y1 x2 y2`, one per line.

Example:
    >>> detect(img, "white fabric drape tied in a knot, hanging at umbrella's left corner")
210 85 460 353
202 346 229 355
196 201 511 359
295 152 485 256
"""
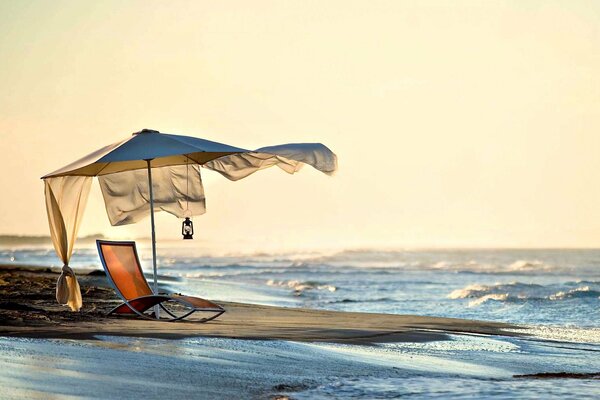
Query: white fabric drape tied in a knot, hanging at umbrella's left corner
44 176 92 311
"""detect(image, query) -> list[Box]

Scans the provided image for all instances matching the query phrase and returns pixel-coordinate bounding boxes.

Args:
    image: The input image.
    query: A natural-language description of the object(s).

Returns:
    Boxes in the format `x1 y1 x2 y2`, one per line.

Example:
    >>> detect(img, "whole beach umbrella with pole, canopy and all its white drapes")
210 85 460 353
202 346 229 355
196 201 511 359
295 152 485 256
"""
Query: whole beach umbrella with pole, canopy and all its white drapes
42 129 337 310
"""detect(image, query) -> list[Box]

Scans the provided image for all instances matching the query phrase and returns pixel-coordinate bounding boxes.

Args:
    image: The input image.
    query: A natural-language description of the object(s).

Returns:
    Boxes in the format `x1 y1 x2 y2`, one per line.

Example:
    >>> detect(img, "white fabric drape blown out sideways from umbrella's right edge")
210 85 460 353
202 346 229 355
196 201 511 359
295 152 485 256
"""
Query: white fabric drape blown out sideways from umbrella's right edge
203 143 337 181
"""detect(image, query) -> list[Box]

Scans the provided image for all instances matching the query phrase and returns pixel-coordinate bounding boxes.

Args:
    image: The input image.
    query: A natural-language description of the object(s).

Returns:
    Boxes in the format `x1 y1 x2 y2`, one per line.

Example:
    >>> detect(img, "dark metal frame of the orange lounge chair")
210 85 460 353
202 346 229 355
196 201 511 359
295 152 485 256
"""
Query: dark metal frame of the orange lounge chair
96 240 225 322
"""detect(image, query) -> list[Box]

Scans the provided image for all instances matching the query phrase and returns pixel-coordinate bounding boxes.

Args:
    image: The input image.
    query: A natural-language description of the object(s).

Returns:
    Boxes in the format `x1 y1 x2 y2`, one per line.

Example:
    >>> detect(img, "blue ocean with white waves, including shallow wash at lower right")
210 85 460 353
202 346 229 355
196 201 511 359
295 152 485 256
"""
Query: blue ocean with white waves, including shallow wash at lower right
0 243 600 399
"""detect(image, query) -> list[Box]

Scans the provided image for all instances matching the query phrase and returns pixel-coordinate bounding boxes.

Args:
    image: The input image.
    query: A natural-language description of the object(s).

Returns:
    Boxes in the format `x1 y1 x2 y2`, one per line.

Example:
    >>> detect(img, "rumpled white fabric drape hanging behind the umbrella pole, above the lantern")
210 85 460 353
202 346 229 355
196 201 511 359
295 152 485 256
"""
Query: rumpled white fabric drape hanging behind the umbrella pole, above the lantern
98 163 206 225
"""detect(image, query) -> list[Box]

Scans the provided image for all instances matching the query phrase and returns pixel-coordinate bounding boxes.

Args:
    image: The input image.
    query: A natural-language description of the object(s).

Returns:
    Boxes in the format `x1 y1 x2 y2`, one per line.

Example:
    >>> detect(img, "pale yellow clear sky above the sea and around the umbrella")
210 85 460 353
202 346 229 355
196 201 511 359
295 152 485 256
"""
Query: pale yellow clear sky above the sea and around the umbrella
0 0 600 251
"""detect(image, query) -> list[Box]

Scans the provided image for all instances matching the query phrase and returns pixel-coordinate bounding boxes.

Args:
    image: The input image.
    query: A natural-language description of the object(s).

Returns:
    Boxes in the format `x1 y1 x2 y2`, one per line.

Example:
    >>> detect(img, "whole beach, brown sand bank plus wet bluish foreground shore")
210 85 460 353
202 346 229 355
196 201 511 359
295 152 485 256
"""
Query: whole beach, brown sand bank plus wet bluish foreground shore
0 266 600 399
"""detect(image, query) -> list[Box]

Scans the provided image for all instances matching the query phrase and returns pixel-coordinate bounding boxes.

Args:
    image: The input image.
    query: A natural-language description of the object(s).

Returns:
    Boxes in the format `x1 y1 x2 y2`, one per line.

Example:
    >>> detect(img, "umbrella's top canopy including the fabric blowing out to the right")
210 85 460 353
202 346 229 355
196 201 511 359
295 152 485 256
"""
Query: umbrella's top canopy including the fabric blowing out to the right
42 129 337 180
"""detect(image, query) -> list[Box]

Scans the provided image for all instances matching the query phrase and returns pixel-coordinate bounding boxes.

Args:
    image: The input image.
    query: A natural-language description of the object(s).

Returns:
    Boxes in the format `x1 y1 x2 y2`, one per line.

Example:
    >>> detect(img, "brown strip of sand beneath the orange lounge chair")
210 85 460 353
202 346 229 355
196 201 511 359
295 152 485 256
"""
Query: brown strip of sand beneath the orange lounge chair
0 265 518 345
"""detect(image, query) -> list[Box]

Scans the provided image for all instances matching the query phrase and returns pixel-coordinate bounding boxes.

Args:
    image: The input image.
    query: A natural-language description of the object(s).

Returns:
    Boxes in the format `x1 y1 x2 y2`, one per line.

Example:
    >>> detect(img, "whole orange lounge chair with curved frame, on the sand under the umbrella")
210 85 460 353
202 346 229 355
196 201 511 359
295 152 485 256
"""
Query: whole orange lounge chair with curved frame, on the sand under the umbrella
96 240 225 322
